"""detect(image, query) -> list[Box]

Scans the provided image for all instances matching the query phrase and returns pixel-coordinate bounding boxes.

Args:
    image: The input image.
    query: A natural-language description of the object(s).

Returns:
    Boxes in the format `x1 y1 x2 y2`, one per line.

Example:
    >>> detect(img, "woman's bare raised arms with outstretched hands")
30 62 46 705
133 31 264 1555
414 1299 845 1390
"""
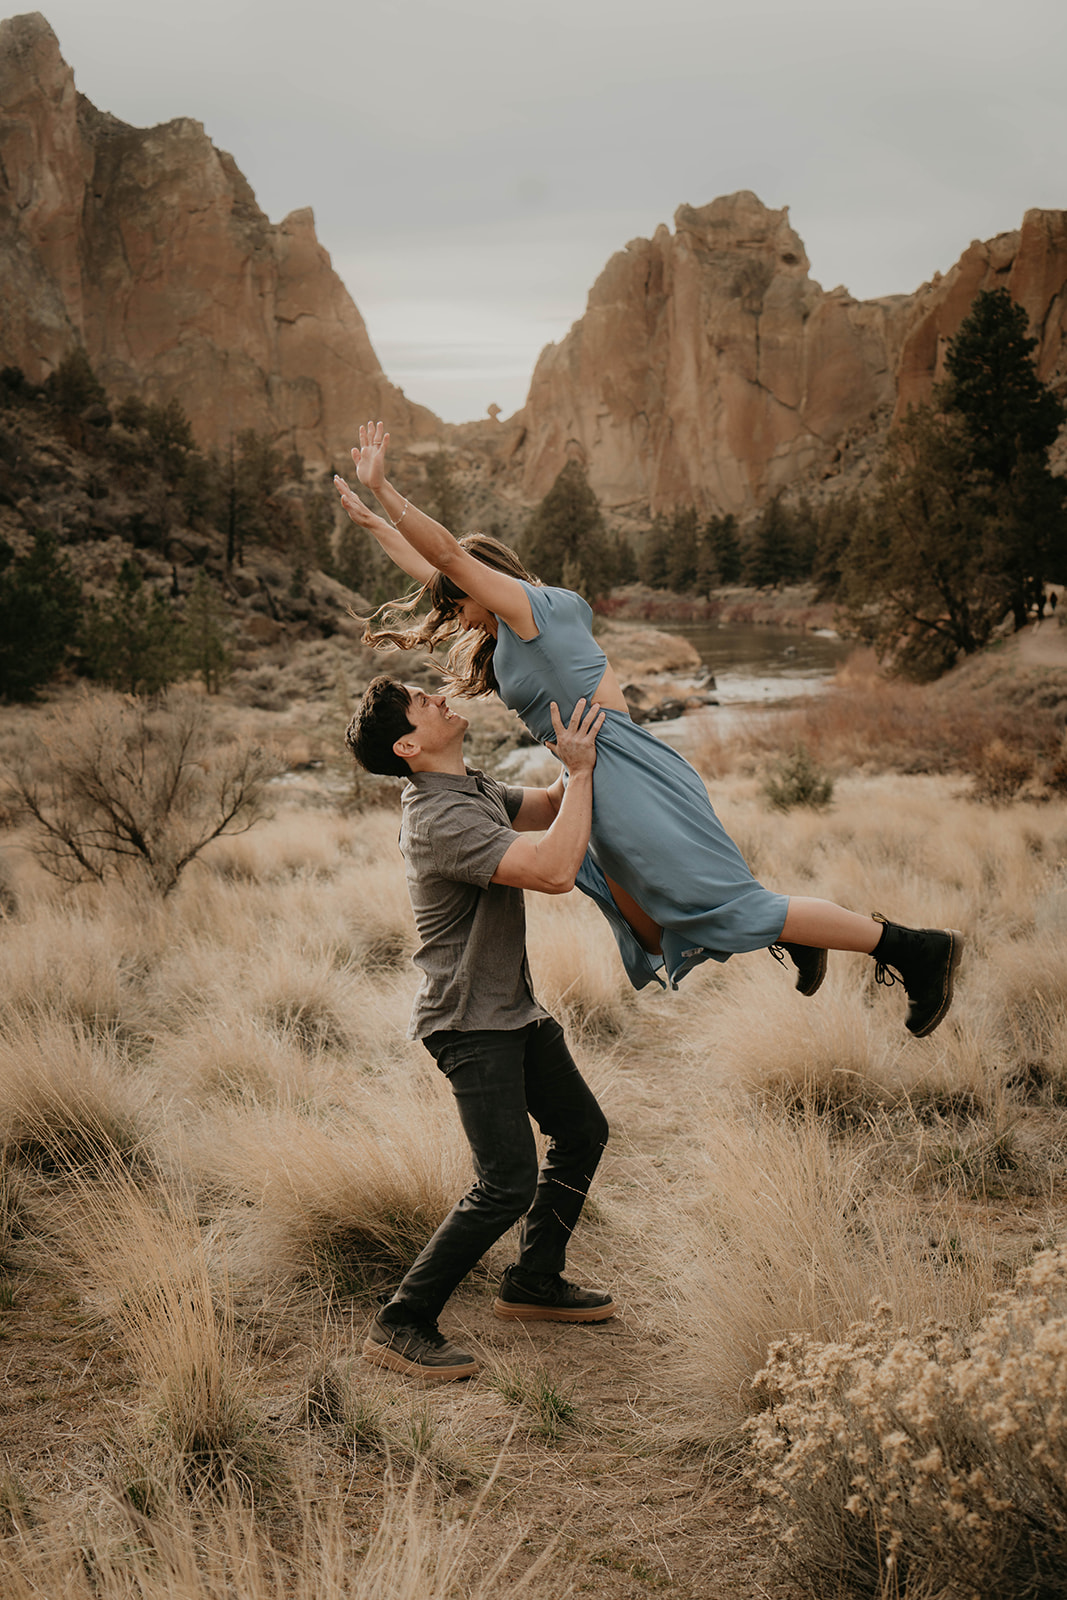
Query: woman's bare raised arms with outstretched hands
336 422 537 638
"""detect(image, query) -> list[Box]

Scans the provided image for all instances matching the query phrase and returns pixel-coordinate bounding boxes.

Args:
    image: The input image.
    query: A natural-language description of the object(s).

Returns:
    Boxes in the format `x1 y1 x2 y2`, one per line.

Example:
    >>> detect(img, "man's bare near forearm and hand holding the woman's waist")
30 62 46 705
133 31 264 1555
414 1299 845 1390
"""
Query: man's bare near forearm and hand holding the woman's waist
493 699 605 894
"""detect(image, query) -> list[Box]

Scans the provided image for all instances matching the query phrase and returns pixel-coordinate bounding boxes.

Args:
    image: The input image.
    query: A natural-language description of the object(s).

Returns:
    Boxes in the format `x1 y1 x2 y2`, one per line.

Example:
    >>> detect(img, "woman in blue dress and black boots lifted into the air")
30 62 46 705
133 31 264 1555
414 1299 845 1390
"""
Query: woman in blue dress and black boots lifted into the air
334 422 961 1037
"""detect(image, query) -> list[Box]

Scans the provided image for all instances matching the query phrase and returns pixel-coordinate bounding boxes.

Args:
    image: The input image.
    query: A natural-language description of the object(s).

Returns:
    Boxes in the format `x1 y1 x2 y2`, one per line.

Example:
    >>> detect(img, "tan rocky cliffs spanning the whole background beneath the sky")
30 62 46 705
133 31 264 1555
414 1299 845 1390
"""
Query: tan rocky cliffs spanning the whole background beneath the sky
0 13 1067 521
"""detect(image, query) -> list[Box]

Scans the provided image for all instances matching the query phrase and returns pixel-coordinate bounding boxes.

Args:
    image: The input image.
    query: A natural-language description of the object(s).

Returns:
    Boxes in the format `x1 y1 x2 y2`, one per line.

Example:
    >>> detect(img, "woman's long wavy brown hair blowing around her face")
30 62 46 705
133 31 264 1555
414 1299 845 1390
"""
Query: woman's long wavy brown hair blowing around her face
363 533 537 699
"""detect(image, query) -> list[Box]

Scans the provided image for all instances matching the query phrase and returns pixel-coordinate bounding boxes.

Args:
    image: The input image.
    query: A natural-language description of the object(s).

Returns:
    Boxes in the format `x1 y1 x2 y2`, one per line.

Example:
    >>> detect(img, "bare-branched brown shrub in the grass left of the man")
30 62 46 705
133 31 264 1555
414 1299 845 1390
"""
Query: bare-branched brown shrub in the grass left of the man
10 694 278 894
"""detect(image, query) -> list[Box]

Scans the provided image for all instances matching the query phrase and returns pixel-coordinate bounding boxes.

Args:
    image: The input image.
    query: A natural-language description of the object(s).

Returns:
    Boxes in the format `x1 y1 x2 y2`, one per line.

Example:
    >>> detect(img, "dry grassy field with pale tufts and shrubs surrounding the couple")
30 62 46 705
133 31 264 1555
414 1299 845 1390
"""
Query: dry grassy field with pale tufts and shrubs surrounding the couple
0 643 1067 1600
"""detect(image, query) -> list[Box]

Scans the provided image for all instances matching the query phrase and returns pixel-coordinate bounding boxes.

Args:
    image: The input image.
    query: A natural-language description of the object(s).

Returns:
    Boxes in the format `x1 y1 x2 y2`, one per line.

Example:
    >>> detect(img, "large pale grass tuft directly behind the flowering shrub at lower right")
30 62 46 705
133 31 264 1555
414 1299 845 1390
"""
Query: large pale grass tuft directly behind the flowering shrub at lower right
659 1110 993 1438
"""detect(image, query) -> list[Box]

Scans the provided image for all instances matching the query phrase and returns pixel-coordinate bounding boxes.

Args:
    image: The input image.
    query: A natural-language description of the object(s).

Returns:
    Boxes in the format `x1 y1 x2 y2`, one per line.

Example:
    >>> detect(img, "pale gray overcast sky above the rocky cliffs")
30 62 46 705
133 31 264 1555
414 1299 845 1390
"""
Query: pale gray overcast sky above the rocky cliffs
27 0 1067 421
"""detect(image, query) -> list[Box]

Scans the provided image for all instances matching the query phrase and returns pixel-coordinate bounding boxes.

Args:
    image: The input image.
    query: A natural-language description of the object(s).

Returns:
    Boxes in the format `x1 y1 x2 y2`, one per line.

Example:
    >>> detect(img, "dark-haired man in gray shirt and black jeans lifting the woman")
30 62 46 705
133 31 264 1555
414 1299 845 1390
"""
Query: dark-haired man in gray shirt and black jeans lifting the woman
346 677 614 1379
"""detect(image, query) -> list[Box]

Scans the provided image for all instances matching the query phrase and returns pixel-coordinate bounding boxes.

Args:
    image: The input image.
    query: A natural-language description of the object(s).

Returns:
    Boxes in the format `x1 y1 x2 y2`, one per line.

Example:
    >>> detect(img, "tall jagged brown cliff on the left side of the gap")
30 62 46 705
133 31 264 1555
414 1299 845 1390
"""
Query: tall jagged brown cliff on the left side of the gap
0 13 443 464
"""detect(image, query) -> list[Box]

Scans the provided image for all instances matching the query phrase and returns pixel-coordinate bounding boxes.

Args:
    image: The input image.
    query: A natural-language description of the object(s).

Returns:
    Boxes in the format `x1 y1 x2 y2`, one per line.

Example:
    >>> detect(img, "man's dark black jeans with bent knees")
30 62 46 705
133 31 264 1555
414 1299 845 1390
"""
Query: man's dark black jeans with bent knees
394 1018 608 1322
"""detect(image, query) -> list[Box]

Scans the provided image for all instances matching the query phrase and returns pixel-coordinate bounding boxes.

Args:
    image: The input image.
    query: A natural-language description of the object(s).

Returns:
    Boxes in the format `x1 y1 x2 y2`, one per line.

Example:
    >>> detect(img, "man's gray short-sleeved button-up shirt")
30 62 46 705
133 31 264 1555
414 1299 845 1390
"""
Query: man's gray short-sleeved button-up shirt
400 771 549 1038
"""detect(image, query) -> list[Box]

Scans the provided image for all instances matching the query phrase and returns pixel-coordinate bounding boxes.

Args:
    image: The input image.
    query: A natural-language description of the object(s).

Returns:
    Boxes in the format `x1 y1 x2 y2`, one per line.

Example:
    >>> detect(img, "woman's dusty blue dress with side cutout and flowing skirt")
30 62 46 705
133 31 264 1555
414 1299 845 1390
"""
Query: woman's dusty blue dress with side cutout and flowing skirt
493 584 789 989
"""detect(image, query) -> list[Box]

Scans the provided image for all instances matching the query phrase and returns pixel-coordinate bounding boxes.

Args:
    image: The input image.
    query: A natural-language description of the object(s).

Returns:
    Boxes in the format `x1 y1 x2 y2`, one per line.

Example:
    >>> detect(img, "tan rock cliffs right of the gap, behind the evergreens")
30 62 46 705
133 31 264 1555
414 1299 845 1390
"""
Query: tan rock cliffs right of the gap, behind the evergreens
507 192 1067 514
